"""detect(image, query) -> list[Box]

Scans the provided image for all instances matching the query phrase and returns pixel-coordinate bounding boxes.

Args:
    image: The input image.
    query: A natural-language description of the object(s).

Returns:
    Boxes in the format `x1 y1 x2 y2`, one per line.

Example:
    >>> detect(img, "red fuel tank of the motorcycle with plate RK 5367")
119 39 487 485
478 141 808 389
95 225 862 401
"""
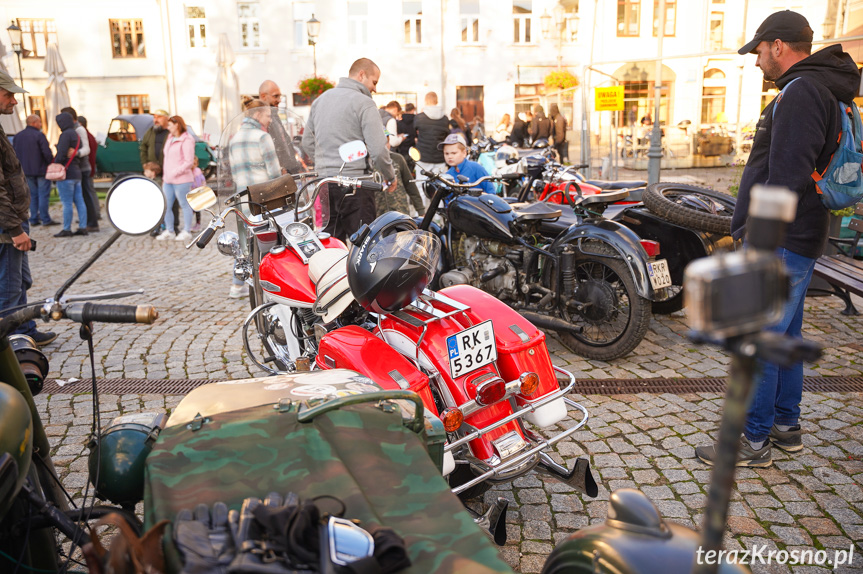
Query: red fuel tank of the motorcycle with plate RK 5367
260 237 345 308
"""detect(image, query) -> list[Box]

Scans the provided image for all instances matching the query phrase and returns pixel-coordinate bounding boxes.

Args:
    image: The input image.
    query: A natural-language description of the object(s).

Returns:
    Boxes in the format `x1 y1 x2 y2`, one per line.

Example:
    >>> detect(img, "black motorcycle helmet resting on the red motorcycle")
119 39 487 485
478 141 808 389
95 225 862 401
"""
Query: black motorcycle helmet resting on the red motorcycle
348 211 440 313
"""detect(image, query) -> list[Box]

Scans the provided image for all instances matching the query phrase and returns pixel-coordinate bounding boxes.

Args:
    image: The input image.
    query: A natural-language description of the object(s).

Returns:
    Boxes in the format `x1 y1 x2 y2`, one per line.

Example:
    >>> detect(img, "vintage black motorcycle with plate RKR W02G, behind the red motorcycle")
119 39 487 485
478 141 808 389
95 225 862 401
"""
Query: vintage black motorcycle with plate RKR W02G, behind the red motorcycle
420 166 670 360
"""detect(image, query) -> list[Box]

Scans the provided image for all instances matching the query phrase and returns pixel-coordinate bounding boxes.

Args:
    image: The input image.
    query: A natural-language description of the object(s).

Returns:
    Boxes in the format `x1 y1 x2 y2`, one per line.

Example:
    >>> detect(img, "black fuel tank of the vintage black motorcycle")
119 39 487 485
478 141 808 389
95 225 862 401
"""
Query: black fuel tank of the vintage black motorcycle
446 193 515 243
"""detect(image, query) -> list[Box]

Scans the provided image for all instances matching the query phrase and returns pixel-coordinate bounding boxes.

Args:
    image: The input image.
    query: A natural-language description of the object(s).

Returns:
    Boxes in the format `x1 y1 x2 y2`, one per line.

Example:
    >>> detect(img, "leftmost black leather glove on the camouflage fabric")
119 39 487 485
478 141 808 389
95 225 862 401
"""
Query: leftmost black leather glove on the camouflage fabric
174 502 236 574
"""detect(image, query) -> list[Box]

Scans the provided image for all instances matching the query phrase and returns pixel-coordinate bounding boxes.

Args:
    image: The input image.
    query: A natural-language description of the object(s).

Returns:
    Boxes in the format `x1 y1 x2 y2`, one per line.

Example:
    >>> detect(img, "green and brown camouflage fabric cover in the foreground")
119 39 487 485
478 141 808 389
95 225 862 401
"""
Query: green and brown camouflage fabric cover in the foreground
144 405 511 573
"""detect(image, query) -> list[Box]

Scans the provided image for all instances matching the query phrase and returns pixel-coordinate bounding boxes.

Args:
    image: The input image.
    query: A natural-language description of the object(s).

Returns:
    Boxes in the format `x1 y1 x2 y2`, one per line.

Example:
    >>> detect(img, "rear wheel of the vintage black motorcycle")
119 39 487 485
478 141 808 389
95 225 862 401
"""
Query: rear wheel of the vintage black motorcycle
560 241 651 361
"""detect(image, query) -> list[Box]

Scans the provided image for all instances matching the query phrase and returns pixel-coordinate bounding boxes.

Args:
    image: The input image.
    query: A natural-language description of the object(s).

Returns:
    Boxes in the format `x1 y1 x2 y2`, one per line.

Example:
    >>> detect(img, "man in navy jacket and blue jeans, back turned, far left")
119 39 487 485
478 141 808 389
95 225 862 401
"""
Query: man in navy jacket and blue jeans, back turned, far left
12 114 59 226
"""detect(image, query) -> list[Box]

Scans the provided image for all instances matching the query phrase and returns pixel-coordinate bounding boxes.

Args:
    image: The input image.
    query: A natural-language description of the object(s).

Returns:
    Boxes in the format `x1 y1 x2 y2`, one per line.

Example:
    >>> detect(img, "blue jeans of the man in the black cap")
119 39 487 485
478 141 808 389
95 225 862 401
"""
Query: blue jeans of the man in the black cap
744 247 815 442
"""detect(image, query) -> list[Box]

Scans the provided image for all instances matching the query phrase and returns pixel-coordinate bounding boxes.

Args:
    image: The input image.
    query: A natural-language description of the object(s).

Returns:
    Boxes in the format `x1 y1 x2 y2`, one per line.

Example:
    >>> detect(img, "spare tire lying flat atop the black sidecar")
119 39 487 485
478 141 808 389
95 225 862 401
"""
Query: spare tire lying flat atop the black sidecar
642 183 736 235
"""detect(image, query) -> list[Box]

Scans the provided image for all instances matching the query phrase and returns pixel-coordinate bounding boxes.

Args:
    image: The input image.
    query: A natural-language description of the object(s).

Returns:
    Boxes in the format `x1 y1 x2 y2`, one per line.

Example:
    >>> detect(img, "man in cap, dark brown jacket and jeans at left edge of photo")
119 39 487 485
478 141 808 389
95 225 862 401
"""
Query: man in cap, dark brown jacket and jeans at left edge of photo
0 72 57 347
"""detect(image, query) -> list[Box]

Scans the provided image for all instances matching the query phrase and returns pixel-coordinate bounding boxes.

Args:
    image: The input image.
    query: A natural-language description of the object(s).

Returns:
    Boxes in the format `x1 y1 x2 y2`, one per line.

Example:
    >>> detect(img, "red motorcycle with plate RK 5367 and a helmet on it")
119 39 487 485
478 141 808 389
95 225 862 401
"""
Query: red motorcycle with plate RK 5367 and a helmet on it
190 127 597 508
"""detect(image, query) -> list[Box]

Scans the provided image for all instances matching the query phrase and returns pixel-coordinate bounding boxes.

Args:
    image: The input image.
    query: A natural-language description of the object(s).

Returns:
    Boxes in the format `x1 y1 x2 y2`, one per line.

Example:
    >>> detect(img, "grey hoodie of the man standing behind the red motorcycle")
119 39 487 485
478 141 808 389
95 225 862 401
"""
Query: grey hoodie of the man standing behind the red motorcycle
303 78 396 181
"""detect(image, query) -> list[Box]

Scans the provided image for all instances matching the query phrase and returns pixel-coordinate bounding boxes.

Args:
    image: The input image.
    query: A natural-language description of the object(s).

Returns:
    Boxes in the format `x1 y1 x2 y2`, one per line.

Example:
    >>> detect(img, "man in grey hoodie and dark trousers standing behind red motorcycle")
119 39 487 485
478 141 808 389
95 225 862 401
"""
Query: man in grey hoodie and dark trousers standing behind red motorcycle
302 58 396 241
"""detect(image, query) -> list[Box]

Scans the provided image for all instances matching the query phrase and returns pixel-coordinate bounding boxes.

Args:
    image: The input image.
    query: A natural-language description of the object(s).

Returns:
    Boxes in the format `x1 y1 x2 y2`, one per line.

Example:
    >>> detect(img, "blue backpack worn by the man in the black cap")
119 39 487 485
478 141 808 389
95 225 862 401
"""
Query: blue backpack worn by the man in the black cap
773 78 863 210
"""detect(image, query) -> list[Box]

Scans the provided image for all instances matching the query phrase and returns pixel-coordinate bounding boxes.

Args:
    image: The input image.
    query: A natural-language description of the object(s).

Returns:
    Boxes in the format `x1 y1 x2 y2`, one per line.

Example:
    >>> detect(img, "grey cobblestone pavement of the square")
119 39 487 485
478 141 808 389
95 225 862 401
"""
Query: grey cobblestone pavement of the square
23 197 863 572
